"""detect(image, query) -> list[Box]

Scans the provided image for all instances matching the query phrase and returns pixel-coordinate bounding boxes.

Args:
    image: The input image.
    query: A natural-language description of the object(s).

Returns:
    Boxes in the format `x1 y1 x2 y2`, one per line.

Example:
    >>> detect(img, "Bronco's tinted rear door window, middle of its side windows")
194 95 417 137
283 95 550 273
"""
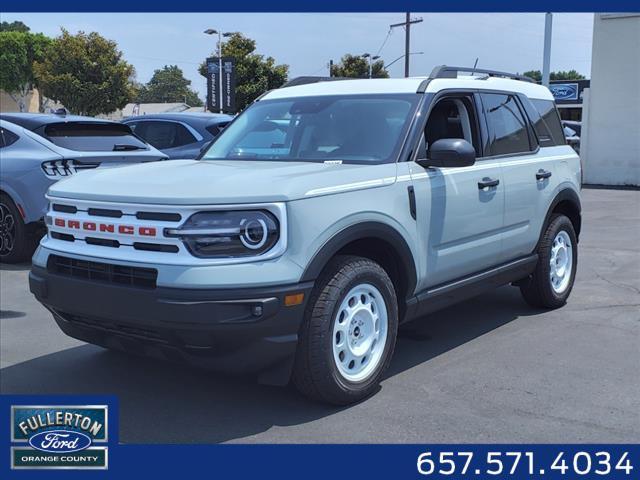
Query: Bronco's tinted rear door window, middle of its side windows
480 93 532 155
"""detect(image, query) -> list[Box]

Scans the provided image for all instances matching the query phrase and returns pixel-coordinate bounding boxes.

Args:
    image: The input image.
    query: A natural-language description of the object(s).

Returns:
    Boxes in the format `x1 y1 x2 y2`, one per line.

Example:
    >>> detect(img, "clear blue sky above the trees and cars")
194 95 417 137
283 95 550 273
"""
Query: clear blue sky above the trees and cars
2 13 593 100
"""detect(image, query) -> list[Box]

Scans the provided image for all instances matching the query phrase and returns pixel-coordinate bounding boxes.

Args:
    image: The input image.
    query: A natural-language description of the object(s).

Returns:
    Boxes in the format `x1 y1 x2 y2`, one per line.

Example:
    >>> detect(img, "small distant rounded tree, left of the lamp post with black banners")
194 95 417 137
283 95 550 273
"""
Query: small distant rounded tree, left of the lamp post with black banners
136 65 203 107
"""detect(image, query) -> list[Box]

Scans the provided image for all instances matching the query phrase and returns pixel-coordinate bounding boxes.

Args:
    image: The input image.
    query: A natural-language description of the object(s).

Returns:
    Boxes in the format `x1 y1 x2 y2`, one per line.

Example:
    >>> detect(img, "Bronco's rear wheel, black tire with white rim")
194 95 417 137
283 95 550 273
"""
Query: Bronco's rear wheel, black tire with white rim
520 215 578 308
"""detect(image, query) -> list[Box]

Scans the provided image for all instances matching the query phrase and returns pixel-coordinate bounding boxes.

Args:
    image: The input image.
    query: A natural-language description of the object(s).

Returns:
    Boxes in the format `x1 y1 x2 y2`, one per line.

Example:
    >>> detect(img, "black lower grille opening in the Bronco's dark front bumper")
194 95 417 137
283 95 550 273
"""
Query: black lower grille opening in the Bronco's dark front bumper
47 255 158 288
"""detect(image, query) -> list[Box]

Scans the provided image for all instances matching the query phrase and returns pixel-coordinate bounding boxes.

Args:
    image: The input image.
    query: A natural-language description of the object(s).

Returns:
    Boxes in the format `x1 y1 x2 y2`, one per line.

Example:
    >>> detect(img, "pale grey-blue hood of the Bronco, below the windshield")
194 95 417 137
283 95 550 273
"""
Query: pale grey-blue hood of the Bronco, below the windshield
49 160 396 205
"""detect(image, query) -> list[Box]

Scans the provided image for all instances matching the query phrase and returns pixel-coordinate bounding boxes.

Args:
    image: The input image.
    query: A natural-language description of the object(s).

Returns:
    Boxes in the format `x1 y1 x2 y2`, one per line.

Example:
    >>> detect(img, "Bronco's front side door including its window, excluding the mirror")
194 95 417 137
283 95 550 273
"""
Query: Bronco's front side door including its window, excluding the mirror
411 93 504 289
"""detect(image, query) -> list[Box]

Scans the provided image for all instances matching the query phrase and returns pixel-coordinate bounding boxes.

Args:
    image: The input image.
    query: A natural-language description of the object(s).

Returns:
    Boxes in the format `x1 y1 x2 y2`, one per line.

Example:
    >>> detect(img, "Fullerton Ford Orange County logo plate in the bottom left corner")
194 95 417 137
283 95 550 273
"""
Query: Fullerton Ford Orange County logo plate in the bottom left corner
11 405 109 469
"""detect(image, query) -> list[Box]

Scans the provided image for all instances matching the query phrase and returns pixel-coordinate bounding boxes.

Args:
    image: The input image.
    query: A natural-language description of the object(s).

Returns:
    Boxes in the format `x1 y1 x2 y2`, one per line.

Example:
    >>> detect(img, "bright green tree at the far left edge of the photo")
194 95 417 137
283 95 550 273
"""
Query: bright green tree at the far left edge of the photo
0 31 51 112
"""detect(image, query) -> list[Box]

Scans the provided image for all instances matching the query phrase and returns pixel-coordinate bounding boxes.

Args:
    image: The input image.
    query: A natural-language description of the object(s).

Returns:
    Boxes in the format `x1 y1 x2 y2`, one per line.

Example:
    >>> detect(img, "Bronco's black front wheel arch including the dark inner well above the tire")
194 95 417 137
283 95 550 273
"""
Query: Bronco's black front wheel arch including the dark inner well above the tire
300 222 417 316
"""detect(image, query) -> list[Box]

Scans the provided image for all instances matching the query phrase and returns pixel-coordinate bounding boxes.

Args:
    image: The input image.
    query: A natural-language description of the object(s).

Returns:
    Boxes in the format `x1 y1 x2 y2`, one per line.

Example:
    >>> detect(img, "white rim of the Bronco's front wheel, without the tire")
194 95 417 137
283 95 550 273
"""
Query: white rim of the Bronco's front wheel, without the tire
332 283 389 382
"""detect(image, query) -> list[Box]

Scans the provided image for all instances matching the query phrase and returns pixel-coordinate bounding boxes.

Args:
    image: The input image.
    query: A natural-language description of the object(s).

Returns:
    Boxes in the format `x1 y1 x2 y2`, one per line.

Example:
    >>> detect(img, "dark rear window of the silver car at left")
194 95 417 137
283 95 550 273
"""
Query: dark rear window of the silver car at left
43 122 147 152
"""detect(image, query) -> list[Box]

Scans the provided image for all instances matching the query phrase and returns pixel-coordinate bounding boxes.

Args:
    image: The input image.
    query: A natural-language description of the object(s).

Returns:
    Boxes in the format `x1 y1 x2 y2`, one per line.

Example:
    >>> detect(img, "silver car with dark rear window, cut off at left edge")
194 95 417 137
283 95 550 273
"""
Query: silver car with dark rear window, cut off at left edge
0 113 167 263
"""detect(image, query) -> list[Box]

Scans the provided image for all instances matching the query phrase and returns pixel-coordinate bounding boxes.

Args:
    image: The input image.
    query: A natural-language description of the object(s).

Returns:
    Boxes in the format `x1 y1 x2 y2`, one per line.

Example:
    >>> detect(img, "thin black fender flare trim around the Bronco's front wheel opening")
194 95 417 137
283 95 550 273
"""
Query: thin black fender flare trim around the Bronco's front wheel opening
300 221 417 295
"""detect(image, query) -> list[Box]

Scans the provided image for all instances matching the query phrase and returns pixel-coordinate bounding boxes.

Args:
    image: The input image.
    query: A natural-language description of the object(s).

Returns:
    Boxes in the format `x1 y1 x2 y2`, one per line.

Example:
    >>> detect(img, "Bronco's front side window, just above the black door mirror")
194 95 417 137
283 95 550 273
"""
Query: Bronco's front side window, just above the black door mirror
418 95 481 156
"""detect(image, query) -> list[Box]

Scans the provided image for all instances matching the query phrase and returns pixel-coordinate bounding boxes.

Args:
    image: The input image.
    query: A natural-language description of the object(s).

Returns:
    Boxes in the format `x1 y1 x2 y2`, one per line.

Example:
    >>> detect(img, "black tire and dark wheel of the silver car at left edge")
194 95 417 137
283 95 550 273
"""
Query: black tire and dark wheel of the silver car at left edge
0 193 38 263
